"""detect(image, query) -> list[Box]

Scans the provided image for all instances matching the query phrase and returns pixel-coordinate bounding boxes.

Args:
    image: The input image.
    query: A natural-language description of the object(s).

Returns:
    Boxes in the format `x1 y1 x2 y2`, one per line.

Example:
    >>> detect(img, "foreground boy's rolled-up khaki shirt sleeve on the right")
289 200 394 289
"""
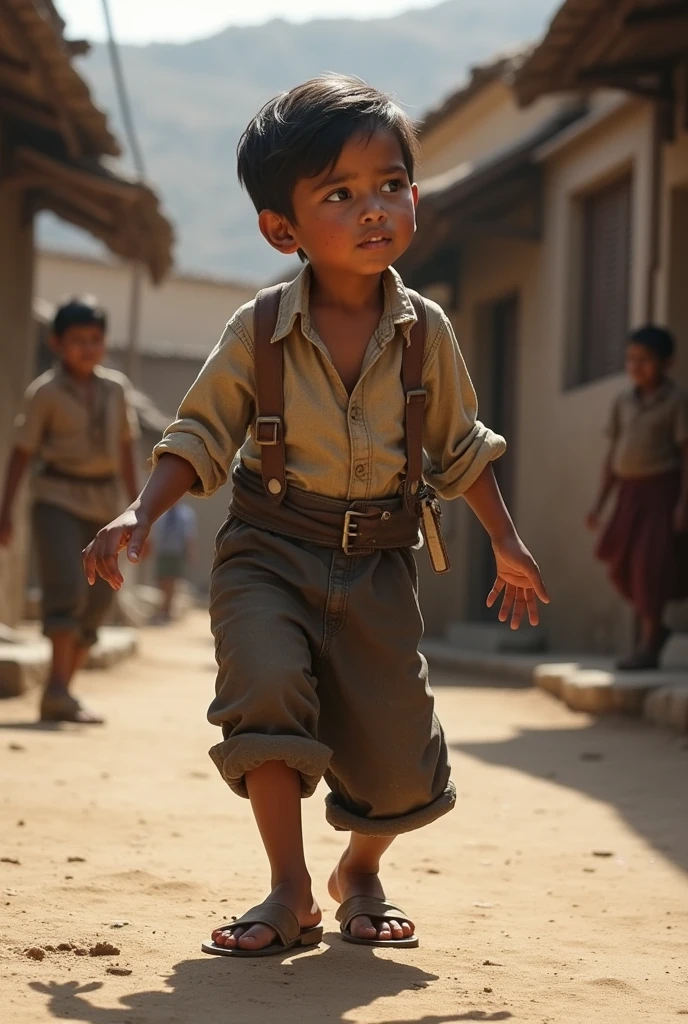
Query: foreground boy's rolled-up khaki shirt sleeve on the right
423 313 507 499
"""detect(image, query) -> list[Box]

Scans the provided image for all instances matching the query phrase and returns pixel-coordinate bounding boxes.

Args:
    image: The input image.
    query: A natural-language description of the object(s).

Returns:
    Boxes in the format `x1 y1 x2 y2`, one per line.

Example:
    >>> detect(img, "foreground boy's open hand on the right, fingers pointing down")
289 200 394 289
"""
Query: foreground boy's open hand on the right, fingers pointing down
487 532 550 630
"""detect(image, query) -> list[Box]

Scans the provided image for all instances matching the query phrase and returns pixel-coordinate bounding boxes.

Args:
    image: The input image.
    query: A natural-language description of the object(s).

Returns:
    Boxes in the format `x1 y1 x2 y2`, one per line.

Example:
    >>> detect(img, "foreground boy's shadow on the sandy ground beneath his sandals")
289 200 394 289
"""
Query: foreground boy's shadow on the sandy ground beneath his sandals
31 936 512 1024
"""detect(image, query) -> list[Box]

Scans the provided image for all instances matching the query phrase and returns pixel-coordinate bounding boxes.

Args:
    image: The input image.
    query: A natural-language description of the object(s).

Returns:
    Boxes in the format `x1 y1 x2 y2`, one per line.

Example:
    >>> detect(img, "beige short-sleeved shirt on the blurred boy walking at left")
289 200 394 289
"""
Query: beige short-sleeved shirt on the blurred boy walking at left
15 364 138 523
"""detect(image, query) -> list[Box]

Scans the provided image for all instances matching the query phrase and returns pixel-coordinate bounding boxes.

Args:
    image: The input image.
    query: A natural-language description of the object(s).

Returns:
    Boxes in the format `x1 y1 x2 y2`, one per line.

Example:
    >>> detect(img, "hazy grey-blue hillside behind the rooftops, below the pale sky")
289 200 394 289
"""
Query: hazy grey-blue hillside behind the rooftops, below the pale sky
43 0 554 280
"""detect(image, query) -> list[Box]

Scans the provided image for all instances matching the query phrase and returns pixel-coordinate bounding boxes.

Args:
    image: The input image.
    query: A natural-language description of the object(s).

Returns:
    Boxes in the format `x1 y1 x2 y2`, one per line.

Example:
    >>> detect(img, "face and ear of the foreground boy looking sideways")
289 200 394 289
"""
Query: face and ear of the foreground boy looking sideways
261 131 418 275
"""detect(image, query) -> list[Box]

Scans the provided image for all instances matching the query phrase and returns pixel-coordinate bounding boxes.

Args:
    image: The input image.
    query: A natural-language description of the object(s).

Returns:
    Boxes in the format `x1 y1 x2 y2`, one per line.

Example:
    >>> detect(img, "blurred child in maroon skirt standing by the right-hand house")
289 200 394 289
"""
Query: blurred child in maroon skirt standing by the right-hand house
588 326 688 671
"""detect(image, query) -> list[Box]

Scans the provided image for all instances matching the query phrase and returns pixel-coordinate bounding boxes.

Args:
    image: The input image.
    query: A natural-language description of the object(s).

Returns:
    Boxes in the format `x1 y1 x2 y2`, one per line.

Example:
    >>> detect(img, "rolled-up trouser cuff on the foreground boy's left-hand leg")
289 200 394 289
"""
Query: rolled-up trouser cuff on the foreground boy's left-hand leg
208 732 332 797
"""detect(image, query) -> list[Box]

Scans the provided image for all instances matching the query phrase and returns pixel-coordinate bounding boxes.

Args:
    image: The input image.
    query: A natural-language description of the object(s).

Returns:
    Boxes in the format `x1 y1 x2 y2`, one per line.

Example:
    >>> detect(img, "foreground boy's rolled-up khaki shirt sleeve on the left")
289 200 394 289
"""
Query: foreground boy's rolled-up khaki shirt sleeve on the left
153 313 255 498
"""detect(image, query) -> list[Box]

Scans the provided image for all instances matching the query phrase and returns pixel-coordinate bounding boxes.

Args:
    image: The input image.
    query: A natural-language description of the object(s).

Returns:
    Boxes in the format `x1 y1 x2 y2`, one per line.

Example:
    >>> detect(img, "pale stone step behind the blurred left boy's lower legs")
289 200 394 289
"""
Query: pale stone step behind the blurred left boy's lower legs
0 626 138 697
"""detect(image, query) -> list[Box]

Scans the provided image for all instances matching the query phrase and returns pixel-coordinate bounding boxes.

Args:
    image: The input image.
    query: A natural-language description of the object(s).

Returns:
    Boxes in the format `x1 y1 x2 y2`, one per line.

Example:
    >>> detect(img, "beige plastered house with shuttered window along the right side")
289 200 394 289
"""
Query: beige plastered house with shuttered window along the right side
400 0 688 651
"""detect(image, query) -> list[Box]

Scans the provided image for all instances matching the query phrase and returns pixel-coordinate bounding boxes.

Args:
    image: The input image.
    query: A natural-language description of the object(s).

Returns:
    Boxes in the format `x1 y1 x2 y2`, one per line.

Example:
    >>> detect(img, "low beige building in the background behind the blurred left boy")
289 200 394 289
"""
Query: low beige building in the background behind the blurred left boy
36 249 256 593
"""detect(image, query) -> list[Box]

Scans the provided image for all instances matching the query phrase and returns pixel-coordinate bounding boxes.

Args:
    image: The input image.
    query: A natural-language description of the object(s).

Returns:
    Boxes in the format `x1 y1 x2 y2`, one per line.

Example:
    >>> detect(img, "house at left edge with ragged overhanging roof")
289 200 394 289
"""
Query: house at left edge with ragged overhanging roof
0 0 172 625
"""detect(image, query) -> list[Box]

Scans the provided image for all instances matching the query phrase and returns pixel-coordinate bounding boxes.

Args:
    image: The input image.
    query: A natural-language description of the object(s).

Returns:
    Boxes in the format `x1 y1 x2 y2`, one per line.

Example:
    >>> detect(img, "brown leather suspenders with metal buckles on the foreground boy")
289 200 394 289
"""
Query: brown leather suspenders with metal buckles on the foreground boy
249 285 427 514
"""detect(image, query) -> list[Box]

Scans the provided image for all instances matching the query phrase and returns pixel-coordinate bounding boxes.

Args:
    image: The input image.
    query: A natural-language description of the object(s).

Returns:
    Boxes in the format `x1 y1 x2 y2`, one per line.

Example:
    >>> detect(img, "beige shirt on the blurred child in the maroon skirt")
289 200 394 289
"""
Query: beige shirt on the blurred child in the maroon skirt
607 379 688 479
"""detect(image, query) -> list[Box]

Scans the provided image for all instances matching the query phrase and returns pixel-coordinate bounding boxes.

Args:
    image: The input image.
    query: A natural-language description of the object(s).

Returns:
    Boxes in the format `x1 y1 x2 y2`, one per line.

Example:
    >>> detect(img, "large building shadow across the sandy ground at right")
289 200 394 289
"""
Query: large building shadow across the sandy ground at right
453 717 688 872
